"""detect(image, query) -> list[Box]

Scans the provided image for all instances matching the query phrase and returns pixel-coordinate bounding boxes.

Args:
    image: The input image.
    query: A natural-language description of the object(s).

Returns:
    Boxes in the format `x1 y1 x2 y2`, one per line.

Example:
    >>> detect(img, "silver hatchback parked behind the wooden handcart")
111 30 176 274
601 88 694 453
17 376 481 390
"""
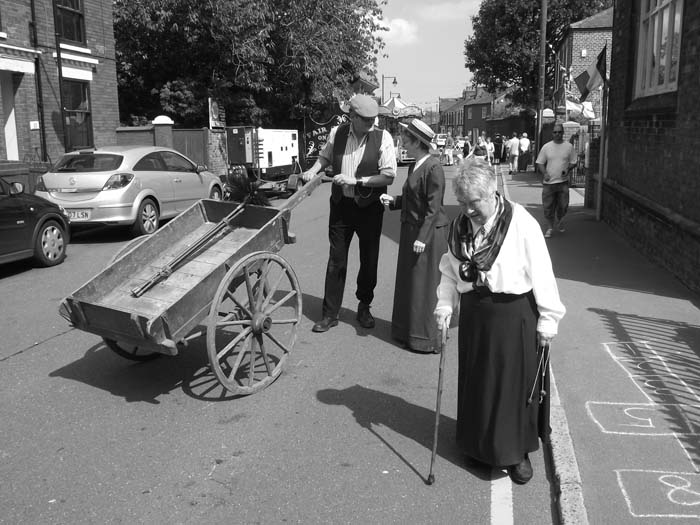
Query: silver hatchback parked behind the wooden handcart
35 146 222 235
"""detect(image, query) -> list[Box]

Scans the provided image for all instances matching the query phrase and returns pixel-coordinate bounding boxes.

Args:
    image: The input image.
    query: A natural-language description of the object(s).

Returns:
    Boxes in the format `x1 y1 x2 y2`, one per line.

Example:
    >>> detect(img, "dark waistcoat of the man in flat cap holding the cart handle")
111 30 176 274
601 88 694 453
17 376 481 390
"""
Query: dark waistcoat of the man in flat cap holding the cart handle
331 124 387 208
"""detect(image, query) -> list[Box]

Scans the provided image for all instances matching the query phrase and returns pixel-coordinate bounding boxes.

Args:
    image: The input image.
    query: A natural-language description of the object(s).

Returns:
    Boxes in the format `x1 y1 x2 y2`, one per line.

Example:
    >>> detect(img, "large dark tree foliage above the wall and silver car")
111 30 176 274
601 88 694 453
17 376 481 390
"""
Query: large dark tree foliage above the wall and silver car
114 0 386 126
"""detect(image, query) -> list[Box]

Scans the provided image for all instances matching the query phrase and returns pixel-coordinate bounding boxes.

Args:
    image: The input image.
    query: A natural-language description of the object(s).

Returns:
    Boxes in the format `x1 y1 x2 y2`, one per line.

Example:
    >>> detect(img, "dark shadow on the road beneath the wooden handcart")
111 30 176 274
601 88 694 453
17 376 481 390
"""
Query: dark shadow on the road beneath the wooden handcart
49 342 242 405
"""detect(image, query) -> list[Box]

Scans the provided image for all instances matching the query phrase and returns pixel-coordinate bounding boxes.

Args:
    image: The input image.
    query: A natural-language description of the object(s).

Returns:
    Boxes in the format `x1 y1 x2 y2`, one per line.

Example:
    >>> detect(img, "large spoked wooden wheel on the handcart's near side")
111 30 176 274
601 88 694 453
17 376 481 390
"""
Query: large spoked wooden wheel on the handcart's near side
207 252 301 395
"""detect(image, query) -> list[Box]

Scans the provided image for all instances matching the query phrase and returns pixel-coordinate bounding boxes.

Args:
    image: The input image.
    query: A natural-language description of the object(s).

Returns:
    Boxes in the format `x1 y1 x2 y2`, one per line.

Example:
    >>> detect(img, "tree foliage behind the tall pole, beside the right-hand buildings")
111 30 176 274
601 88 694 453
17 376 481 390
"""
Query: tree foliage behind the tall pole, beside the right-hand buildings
464 0 613 107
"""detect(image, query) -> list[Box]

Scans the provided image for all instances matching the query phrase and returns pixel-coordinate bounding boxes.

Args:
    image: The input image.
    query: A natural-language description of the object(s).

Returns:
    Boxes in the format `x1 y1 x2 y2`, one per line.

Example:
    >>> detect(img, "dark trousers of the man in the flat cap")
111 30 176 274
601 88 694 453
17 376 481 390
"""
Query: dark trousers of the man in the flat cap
323 197 384 319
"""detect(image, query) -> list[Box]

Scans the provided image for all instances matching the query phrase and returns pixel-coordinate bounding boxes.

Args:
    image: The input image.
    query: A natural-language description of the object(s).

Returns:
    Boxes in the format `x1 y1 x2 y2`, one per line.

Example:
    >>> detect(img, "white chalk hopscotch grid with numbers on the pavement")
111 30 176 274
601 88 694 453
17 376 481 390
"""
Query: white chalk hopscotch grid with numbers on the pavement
586 340 700 519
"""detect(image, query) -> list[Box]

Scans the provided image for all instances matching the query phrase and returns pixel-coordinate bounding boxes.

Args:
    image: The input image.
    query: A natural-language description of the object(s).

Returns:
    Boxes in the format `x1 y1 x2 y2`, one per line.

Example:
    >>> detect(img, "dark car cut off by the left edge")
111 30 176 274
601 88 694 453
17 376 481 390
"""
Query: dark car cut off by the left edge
0 179 70 266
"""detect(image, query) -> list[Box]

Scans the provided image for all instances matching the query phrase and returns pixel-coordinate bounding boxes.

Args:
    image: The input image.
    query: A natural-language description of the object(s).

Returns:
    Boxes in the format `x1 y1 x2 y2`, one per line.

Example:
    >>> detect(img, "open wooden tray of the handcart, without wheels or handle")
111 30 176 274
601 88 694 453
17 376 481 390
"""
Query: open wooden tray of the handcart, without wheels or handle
58 200 290 354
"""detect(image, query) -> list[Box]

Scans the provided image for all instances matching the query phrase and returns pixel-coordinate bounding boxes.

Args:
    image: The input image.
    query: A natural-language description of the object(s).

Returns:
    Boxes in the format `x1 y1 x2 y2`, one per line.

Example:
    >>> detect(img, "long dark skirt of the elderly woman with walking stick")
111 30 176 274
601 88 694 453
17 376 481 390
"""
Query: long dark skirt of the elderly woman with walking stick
457 291 549 467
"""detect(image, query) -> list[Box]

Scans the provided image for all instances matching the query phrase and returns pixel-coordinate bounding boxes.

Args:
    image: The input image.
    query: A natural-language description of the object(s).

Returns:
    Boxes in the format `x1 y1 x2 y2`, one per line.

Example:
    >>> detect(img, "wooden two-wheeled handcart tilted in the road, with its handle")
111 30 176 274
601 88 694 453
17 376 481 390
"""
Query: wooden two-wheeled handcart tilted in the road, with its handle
59 175 321 394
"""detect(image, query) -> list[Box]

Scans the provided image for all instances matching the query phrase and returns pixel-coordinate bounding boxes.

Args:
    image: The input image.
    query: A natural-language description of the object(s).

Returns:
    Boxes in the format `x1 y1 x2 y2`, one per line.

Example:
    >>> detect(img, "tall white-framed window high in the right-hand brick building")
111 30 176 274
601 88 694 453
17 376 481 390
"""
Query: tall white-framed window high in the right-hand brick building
635 0 683 97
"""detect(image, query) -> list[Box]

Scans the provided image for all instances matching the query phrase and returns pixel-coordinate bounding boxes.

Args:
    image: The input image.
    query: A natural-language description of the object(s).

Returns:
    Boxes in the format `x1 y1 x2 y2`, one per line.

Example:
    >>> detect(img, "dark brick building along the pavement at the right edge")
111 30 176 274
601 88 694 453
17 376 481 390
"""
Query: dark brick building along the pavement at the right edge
601 0 700 291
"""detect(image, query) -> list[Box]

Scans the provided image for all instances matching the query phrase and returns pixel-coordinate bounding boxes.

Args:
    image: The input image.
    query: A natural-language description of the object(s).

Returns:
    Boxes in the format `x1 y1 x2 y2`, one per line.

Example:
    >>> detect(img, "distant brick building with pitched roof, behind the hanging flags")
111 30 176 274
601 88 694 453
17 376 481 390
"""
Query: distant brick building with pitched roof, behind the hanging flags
554 7 613 118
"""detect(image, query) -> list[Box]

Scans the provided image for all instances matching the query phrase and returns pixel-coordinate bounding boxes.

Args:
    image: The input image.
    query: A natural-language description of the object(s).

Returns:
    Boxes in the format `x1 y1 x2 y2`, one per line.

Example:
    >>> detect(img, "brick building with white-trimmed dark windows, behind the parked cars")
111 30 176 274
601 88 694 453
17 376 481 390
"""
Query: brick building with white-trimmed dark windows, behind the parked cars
0 0 119 164
